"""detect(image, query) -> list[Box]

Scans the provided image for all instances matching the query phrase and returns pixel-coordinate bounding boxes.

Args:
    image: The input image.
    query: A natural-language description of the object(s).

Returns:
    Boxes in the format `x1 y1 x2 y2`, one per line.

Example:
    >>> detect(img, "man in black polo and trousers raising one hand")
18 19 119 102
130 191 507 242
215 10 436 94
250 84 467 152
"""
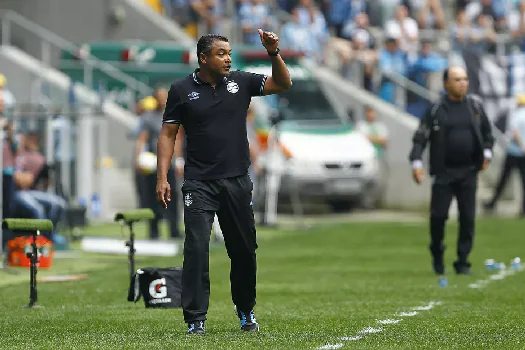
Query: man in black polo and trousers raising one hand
157 29 292 334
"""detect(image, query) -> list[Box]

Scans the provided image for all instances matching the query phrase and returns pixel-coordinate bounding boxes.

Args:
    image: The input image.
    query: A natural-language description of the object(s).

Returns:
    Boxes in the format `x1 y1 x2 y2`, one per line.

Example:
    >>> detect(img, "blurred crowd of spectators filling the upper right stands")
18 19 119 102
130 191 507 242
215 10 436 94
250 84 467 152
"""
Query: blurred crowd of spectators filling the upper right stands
144 0 525 116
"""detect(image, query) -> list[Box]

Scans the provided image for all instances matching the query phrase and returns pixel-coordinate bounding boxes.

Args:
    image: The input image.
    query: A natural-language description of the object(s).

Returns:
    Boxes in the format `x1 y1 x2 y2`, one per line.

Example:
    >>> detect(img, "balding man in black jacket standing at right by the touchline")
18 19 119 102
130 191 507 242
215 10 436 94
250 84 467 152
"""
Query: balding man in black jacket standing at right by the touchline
409 67 494 275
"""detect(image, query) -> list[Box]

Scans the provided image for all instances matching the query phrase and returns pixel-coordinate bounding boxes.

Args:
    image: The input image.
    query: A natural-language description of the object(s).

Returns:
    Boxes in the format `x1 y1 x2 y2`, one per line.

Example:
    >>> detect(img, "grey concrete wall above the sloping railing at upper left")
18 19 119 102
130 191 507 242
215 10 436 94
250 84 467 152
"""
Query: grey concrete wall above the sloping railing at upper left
0 0 193 63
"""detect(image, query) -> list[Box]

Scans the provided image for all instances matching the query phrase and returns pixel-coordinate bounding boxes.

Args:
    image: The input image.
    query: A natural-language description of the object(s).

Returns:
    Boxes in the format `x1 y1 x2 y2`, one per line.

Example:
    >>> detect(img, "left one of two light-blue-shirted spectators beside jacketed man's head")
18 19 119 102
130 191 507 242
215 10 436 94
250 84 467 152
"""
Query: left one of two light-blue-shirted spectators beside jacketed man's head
379 38 408 104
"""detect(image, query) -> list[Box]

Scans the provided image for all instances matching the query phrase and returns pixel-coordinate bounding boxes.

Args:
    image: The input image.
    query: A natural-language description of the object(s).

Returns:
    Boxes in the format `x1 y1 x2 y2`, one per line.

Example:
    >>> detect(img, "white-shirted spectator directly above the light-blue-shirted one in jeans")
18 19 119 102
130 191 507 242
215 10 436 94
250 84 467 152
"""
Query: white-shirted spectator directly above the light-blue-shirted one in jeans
385 5 419 52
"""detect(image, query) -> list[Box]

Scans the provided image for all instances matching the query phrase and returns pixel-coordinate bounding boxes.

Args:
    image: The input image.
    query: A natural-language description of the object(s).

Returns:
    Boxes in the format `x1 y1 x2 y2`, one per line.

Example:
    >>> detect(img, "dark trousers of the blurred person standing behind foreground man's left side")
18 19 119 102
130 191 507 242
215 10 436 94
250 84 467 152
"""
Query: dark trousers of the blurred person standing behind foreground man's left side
142 168 180 239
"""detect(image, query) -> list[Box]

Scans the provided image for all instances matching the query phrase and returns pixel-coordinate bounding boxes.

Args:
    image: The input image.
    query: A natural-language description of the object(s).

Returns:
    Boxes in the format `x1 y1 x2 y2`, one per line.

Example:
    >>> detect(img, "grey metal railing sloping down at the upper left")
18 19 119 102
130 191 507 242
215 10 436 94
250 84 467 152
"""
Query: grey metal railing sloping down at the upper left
0 11 153 108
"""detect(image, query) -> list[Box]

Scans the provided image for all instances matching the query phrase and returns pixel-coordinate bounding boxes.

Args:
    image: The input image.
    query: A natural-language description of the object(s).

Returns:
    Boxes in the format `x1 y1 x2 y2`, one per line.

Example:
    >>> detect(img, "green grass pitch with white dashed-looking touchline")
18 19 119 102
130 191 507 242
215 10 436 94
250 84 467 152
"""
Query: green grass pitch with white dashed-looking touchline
0 219 525 350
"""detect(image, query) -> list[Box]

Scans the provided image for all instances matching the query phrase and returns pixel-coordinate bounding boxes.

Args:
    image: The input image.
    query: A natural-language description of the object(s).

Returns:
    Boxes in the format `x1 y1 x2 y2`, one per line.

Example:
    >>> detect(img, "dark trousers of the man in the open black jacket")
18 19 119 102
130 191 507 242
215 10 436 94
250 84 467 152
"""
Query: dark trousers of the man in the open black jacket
430 170 478 274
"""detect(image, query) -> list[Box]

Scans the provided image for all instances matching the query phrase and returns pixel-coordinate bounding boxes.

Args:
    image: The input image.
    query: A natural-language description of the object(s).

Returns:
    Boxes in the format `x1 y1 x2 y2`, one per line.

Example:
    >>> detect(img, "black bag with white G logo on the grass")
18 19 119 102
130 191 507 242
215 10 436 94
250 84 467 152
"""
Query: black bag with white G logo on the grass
128 267 182 308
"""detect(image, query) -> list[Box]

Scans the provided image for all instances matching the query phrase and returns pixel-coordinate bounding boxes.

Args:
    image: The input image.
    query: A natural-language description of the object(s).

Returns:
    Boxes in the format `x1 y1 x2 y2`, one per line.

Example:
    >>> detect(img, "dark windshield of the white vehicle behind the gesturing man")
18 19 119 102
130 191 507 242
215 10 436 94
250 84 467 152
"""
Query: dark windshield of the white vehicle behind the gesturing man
260 79 342 124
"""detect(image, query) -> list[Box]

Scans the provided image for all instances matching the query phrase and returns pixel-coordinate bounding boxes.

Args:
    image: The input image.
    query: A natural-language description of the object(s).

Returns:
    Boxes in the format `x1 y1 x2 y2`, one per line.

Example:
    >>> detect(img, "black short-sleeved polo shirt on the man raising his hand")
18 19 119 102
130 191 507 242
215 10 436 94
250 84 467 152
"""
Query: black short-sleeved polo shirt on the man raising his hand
163 69 267 180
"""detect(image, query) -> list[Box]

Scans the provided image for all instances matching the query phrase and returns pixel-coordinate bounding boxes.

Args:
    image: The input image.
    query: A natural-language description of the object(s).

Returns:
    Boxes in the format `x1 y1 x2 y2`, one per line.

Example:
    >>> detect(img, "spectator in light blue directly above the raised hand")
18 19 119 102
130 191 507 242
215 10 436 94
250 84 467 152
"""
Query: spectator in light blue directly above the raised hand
239 0 271 45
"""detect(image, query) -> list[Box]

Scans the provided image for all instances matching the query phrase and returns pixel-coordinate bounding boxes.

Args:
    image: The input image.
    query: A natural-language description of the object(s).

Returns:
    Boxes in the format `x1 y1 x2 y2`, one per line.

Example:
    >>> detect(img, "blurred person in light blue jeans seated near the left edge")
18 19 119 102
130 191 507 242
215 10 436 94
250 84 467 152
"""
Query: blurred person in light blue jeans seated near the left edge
13 132 67 239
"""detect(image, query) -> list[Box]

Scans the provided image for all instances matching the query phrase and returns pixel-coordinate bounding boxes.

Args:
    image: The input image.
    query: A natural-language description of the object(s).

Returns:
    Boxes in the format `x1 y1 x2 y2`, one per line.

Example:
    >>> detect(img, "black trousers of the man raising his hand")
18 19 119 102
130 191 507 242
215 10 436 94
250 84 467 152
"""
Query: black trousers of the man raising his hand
182 175 257 323
